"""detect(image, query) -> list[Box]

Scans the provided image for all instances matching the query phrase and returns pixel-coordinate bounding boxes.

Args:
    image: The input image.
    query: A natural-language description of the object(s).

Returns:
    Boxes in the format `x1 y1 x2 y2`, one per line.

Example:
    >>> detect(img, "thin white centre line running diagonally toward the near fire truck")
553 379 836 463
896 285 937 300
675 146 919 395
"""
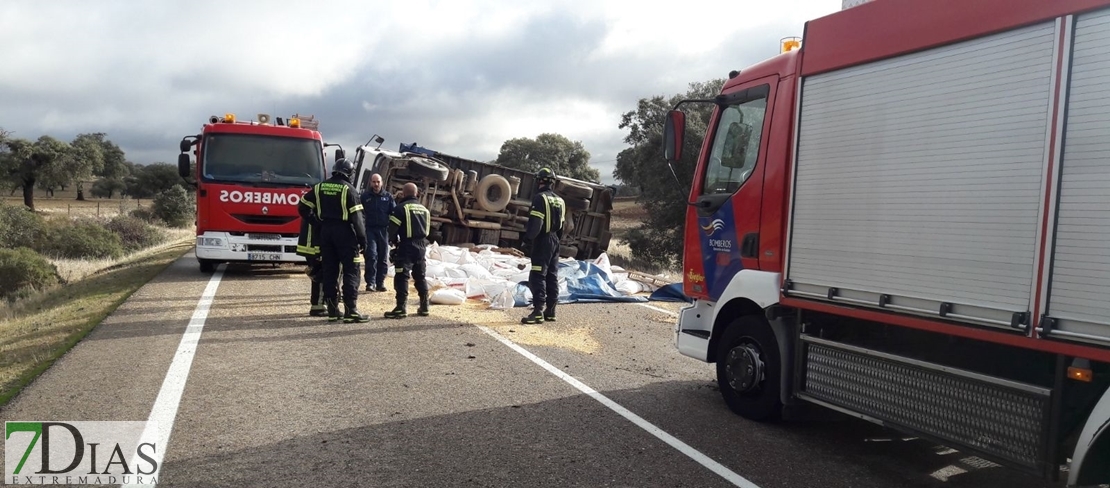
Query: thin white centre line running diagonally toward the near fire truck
475 323 759 488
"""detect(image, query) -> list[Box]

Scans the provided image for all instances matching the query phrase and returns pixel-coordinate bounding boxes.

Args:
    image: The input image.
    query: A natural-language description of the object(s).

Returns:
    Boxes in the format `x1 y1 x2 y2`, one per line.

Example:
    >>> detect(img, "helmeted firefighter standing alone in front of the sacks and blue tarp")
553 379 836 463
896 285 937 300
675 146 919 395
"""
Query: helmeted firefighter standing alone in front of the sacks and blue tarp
521 167 566 324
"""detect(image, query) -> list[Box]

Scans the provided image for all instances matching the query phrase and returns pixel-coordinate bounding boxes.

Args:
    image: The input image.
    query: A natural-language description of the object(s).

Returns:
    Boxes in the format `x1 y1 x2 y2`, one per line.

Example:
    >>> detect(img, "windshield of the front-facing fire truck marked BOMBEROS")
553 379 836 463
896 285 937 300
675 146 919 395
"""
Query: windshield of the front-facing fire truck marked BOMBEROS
201 133 324 186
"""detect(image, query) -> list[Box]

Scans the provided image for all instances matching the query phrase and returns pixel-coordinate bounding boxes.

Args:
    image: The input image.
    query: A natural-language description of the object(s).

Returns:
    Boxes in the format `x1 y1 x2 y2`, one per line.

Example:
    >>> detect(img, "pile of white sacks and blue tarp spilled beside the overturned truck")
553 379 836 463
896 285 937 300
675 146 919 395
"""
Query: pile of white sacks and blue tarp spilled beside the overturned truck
404 243 655 309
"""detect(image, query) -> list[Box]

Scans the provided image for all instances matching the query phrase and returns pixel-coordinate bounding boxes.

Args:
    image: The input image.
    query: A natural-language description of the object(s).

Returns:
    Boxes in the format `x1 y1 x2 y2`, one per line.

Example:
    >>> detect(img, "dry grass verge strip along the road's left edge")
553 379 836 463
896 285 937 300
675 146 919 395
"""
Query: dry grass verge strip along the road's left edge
0 242 192 406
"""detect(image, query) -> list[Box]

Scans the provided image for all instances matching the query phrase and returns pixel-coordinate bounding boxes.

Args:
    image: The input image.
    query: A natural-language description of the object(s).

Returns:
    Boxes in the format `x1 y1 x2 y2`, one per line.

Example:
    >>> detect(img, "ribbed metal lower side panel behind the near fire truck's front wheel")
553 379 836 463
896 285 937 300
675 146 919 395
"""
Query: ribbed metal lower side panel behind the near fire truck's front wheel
803 337 1050 470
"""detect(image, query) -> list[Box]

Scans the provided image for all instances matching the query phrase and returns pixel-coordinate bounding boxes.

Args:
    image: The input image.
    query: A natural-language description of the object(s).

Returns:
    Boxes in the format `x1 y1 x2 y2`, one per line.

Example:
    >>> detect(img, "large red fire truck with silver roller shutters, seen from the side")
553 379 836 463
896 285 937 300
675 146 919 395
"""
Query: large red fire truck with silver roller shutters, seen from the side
664 0 1110 485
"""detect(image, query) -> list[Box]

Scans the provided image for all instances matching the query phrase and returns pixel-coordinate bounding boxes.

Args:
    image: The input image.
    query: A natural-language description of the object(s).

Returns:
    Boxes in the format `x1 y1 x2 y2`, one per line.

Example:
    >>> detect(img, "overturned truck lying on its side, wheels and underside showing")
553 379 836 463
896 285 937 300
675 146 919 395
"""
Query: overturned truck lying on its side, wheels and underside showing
354 138 613 260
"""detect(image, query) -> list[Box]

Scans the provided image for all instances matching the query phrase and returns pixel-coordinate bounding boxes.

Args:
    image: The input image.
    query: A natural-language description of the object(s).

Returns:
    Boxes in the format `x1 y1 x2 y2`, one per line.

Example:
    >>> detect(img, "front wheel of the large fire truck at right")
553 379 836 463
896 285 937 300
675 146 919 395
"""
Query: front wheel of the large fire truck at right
716 315 783 421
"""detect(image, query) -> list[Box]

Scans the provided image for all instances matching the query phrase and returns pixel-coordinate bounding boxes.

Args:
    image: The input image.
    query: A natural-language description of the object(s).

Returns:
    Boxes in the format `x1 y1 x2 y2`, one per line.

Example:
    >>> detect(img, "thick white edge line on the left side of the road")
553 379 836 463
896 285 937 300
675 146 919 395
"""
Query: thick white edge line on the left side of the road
121 265 224 487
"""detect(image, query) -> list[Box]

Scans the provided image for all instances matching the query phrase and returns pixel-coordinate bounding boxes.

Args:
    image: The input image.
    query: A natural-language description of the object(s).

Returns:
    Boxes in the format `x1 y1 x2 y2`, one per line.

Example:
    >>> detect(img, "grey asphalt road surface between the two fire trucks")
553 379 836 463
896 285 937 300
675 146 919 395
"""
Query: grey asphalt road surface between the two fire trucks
0 255 1062 488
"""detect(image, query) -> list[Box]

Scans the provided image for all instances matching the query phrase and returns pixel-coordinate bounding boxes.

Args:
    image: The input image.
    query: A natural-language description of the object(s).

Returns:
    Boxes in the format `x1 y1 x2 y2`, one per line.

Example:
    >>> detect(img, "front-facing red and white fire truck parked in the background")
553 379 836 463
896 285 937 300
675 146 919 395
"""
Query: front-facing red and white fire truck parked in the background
178 113 333 273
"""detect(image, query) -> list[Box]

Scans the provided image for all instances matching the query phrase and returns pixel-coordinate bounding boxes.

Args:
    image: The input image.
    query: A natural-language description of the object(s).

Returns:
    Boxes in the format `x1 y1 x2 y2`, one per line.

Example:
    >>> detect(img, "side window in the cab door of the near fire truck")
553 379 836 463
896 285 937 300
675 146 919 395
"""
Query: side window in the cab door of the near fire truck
702 95 767 195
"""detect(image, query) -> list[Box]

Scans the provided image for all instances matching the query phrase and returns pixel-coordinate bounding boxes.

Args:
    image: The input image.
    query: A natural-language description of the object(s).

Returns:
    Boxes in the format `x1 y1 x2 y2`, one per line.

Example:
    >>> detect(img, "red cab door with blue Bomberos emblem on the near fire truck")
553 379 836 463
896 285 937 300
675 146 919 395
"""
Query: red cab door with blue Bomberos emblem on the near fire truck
684 75 778 301
